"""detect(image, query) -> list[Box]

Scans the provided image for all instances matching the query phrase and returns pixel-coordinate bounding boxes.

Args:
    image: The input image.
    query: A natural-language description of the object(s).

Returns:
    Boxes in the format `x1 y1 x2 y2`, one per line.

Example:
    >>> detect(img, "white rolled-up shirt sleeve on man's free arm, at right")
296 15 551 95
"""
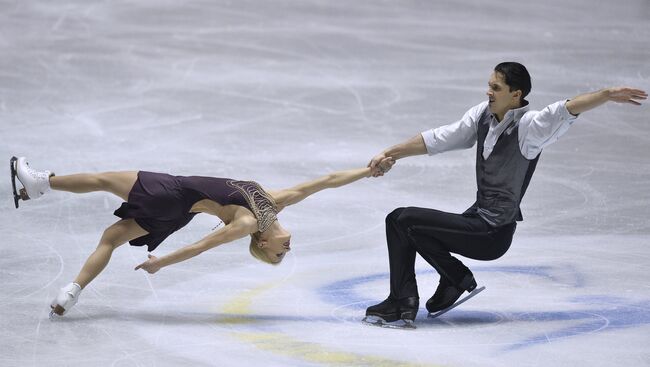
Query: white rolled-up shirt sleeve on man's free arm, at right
519 100 578 159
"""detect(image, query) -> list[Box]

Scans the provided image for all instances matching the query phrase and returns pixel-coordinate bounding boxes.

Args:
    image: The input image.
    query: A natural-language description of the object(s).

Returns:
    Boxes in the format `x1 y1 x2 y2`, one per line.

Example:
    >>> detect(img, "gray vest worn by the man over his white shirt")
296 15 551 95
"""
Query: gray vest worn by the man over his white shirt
464 108 541 227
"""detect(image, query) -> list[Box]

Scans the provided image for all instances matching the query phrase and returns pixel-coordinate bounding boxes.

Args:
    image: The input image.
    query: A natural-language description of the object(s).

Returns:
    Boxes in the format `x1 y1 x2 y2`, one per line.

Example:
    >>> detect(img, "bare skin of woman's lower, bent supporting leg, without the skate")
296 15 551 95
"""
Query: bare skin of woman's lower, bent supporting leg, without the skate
73 220 148 289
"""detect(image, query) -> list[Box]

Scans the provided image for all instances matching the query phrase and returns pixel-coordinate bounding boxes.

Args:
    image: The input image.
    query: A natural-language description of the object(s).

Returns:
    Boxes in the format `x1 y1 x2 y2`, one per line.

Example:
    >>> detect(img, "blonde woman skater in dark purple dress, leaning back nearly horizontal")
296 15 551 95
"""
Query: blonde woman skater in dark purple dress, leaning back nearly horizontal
10 157 394 316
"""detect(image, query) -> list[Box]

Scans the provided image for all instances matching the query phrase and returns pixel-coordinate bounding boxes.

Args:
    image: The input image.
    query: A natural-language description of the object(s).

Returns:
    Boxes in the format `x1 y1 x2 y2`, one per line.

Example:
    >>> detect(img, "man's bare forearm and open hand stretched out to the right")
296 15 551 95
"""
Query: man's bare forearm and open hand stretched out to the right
566 87 648 116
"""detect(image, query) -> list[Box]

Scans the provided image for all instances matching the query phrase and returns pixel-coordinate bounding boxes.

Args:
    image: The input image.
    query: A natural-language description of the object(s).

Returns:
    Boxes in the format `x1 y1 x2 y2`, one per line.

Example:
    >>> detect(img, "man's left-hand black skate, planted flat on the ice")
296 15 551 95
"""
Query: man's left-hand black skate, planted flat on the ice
362 296 420 329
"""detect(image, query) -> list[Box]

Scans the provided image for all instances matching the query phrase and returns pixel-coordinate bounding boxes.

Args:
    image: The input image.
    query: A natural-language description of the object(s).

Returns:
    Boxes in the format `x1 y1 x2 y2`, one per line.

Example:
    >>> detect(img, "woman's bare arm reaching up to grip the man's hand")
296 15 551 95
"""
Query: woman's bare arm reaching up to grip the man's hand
271 164 394 207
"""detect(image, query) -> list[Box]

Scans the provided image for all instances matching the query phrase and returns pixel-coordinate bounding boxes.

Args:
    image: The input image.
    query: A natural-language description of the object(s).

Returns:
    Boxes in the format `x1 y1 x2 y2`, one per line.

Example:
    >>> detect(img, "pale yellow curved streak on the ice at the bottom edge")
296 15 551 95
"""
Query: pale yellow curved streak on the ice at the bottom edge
233 333 446 367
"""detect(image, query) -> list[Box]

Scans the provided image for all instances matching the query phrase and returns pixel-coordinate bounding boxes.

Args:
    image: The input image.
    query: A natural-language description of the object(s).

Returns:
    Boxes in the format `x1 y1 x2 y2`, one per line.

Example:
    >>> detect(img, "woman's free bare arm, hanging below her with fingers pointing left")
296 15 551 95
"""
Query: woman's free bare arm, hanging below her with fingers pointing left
135 217 257 274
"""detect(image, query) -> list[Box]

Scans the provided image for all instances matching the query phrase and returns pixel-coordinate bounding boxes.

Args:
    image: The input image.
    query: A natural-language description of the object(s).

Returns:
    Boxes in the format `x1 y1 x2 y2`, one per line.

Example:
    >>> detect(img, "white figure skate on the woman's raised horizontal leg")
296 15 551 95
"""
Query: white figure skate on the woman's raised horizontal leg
9 157 54 209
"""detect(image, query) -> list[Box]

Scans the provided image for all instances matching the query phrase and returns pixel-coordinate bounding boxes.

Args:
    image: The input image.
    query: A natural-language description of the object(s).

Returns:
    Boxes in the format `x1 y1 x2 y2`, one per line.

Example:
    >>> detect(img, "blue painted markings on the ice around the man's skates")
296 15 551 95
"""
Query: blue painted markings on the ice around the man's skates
318 264 650 352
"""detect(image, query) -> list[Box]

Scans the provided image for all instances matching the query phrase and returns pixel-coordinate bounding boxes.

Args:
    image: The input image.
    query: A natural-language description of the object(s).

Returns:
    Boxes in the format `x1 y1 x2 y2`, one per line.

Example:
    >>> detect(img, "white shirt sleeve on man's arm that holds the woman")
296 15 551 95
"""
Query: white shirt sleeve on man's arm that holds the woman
421 102 487 155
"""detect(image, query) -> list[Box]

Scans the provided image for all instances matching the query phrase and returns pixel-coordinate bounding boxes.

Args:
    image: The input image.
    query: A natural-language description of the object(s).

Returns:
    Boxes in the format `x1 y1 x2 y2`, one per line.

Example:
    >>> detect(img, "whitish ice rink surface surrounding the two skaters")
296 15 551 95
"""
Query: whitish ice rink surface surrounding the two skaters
0 0 650 367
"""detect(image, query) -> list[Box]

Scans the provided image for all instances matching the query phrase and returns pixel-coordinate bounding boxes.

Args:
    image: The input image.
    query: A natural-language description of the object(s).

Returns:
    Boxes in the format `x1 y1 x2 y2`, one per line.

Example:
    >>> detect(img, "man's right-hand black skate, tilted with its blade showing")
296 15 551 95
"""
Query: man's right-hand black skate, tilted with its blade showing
426 272 485 317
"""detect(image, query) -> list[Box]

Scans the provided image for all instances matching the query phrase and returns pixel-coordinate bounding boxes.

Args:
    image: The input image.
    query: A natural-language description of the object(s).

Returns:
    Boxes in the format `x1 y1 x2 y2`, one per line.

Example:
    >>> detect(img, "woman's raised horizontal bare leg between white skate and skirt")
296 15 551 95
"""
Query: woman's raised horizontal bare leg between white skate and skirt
50 171 138 201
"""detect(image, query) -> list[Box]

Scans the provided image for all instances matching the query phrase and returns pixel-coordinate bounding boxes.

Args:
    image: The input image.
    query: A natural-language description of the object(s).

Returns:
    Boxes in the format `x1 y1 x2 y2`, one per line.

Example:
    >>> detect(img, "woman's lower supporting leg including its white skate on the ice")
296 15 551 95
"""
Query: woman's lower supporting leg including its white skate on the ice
51 219 148 315
